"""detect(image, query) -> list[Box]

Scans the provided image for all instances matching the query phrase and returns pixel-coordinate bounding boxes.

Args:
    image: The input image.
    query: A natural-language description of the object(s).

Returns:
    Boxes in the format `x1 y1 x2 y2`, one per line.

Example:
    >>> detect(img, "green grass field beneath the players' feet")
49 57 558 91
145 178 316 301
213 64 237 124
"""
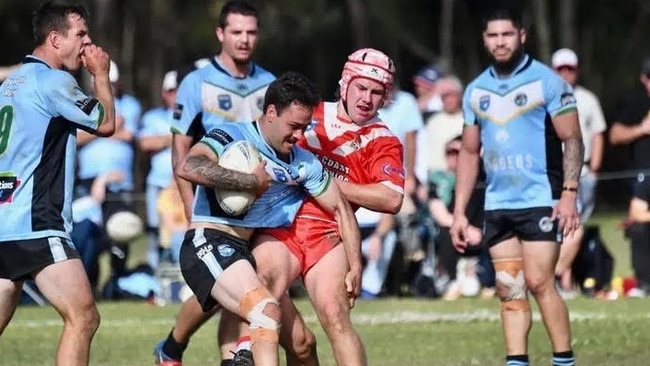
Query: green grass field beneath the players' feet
0 214 636 366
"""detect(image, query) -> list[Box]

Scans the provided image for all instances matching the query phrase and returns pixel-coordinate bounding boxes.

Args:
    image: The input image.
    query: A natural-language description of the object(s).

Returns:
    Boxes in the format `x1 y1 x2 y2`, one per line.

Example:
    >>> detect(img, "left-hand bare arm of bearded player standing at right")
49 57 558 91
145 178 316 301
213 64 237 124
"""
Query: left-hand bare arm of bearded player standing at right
454 125 481 216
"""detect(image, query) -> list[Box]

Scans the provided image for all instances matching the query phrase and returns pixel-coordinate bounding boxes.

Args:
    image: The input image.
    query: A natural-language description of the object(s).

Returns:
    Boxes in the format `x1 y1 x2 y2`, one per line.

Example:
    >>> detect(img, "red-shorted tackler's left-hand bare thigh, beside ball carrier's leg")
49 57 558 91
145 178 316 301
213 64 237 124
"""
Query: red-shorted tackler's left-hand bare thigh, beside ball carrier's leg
252 234 300 299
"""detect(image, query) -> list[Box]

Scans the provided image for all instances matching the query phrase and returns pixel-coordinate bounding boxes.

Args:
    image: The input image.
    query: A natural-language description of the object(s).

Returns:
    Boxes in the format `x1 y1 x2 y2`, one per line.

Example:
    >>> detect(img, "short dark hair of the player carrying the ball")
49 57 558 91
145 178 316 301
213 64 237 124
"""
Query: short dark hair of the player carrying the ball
264 71 320 114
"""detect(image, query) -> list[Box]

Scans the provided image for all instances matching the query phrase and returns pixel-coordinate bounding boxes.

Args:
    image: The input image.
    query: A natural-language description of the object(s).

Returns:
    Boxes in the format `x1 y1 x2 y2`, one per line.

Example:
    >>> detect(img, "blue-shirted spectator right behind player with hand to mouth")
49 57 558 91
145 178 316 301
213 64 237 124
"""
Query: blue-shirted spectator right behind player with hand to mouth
77 60 141 277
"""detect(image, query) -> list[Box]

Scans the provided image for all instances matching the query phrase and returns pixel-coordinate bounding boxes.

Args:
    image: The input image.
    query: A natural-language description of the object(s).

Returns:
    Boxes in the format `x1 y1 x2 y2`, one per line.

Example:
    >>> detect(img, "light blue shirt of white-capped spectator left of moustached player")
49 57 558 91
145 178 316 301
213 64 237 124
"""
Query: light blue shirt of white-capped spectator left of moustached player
138 107 173 187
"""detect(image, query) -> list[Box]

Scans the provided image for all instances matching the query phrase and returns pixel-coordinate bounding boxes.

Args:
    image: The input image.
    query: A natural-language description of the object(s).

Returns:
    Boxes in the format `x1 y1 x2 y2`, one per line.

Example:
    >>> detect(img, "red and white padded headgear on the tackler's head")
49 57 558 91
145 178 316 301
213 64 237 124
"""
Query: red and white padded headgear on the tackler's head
339 48 395 102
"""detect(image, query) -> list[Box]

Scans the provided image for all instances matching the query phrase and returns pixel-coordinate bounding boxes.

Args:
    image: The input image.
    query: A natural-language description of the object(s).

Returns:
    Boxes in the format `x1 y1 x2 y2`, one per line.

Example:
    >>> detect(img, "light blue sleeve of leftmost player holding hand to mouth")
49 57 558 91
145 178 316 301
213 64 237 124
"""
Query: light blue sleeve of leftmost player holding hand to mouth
39 70 104 131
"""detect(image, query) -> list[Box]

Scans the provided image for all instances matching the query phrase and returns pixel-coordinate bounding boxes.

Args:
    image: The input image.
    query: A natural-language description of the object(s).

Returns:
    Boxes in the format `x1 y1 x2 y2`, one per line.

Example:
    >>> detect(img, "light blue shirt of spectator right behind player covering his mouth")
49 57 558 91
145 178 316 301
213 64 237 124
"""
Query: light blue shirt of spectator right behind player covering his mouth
78 94 142 192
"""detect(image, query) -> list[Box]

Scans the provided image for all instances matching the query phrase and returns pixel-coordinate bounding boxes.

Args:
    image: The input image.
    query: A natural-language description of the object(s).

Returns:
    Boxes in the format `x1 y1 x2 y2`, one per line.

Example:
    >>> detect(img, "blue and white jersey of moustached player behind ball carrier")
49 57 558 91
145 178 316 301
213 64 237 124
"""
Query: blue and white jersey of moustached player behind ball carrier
172 58 275 140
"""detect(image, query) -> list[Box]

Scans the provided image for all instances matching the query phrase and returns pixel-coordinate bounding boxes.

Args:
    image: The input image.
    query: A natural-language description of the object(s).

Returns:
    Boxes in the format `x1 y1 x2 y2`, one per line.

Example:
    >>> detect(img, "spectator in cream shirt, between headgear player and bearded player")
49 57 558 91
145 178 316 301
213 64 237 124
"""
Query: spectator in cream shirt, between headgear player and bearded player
424 76 463 175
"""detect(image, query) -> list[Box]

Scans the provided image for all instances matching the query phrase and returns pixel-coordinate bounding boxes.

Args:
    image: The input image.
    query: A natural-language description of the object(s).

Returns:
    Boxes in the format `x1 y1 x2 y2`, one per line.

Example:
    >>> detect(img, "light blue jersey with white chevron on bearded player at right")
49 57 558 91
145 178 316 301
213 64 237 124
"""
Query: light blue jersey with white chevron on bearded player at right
463 55 576 210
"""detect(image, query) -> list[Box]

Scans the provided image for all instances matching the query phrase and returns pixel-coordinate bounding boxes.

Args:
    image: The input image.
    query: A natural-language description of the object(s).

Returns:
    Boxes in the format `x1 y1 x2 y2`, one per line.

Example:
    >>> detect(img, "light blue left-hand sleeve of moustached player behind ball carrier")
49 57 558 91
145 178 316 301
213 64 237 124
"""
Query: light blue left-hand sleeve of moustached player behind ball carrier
172 70 202 135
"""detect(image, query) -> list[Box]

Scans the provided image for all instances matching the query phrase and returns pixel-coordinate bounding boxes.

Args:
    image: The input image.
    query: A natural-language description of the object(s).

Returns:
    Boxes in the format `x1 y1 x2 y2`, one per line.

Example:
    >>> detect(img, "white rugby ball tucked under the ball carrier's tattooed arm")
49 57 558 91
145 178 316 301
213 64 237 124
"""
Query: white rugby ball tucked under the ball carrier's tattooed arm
214 140 262 216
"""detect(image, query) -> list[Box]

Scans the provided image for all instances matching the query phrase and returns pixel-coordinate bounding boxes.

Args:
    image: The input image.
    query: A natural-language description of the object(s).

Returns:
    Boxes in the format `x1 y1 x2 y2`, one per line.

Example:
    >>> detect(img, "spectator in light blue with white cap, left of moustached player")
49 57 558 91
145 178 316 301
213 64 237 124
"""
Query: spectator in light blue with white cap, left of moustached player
138 71 177 270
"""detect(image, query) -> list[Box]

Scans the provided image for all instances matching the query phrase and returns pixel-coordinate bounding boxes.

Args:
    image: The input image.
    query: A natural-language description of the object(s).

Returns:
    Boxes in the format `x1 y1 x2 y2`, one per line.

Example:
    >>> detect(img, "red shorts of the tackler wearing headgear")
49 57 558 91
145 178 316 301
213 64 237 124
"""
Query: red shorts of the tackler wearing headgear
260 217 341 276
